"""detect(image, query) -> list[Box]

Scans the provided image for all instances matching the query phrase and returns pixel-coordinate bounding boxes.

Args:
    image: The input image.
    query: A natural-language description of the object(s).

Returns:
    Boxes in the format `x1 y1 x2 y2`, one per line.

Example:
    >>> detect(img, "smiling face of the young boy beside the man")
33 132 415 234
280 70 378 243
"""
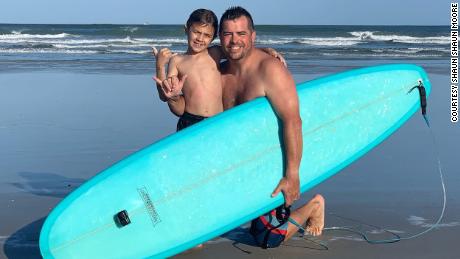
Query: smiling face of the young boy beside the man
186 23 214 53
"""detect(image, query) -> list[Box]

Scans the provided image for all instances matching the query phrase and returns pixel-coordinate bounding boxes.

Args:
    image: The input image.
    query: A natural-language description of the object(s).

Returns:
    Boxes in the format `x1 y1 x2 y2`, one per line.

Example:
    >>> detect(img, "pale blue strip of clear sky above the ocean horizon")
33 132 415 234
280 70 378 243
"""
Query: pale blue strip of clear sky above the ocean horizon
0 0 453 25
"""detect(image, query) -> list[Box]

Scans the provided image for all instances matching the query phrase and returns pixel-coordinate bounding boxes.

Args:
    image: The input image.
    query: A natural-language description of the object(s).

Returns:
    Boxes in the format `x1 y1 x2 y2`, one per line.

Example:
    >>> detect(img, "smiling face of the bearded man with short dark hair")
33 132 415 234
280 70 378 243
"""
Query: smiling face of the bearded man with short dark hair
219 16 256 60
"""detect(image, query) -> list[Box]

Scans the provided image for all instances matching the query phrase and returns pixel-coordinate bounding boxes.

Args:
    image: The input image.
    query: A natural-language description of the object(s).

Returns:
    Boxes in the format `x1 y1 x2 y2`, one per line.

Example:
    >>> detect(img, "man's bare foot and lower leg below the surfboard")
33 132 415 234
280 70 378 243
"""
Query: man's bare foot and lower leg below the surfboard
284 194 325 241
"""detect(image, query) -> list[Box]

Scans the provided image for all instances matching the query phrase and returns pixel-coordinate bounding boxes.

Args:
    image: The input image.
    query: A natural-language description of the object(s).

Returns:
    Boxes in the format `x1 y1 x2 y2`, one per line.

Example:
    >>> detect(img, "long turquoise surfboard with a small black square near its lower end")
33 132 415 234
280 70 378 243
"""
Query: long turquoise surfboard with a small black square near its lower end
40 64 431 259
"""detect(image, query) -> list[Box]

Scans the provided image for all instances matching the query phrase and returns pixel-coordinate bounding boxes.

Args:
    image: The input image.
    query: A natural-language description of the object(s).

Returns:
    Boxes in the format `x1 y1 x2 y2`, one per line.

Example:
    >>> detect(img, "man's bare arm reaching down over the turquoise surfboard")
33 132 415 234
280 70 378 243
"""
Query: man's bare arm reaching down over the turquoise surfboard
262 60 303 206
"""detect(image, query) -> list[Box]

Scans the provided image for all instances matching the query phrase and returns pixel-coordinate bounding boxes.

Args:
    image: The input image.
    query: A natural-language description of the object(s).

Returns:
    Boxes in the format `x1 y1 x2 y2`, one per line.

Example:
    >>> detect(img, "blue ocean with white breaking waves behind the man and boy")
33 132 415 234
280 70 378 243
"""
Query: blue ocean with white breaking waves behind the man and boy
0 24 450 74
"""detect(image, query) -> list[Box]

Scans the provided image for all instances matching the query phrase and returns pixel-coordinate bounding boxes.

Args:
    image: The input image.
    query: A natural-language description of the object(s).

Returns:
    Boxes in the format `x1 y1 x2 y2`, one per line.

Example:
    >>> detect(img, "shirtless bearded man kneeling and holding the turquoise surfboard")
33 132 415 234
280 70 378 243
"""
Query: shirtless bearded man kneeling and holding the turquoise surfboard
219 7 324 247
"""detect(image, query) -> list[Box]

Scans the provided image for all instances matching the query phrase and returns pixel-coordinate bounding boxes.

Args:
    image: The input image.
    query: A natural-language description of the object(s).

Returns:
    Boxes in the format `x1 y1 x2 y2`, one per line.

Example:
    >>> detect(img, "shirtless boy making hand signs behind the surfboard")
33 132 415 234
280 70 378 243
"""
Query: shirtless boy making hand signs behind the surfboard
154 9 223 131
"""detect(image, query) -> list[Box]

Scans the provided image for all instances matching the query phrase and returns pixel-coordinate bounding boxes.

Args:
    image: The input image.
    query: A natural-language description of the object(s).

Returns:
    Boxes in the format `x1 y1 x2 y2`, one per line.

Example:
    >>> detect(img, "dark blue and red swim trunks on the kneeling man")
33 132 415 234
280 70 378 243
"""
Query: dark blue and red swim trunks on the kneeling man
250 209 289 248
